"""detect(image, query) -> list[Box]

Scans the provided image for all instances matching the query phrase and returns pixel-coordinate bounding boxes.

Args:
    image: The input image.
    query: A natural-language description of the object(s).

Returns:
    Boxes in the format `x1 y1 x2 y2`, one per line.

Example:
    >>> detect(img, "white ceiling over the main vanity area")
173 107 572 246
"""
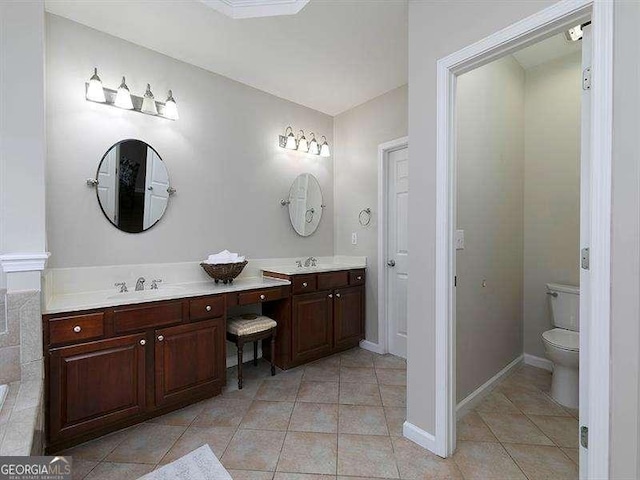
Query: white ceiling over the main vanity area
45 0 408 115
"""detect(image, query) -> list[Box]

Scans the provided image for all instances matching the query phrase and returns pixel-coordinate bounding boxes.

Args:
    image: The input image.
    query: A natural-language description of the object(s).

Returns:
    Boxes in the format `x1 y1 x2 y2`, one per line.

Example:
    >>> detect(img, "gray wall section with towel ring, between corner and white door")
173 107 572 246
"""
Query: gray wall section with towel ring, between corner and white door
334 86 408 343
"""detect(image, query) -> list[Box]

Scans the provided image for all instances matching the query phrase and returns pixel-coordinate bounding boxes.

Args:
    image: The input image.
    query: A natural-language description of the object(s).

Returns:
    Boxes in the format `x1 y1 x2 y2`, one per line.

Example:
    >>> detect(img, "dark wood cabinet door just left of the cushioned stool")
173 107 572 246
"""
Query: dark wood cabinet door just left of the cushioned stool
155 318 225 407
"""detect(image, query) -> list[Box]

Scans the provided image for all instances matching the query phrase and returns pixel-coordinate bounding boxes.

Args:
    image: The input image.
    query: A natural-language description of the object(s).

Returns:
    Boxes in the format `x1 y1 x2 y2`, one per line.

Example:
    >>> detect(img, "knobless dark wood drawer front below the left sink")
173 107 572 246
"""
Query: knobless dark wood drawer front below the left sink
113 301 183 333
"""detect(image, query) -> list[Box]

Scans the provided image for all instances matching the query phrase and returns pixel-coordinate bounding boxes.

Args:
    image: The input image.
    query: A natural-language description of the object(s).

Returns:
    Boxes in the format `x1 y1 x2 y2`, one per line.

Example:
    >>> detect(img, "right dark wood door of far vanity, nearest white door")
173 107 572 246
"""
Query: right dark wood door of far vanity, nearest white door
333 287 365 350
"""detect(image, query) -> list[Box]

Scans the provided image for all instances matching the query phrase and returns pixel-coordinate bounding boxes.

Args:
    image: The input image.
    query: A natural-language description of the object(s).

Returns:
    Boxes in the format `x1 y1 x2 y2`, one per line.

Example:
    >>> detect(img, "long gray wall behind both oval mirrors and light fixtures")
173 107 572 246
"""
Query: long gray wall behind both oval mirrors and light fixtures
46 15 334 267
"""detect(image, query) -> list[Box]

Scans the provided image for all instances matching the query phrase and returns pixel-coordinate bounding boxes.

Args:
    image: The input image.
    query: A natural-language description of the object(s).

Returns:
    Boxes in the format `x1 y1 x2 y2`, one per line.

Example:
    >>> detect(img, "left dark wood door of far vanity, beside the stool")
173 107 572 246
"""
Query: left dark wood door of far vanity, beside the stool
290 292 333 363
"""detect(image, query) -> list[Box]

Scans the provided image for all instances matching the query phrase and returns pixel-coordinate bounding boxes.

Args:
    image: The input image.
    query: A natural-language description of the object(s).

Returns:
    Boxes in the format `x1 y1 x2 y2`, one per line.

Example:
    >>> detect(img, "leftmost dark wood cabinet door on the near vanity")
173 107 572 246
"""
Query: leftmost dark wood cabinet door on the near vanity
48 334 146 440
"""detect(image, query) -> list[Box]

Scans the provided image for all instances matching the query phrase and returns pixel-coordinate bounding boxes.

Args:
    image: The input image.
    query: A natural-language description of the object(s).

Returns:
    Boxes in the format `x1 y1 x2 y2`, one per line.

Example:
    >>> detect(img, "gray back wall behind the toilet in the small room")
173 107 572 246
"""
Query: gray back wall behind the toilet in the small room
523 53 582 358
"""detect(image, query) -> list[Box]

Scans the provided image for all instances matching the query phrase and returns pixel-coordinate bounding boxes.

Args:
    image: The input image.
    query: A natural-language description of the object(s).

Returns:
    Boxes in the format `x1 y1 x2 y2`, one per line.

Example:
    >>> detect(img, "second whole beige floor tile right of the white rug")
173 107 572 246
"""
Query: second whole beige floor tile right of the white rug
277 432 338 475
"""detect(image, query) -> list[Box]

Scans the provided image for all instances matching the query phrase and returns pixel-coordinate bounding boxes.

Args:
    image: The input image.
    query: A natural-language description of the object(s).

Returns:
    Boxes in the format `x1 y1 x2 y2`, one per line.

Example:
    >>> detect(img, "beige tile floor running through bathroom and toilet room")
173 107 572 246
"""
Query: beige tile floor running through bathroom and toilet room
58 349 577 480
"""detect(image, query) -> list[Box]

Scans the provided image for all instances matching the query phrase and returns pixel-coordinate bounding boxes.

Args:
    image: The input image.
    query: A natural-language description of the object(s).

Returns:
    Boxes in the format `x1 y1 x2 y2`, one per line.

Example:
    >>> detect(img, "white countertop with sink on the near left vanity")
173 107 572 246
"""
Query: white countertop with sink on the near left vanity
42 277 291 314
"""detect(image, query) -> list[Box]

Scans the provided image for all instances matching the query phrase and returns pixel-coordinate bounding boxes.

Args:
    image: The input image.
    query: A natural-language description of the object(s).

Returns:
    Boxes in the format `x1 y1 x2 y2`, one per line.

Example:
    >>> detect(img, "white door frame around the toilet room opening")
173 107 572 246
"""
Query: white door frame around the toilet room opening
434 0 613 479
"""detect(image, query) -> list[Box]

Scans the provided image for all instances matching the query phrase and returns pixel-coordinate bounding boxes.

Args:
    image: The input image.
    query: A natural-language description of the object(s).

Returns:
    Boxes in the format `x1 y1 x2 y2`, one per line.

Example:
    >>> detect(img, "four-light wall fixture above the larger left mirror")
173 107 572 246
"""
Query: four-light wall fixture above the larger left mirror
85 68 179 120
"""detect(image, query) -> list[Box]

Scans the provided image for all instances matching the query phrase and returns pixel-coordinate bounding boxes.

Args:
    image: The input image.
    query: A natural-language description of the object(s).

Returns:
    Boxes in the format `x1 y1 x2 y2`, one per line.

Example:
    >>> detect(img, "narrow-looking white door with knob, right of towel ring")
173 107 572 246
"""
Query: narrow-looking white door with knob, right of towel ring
381 147 409 358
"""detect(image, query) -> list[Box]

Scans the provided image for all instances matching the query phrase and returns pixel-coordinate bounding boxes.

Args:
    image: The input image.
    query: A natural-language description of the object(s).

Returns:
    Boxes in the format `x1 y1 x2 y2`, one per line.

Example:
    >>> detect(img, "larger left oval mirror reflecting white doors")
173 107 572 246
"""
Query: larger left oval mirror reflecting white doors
96 140 171 233
